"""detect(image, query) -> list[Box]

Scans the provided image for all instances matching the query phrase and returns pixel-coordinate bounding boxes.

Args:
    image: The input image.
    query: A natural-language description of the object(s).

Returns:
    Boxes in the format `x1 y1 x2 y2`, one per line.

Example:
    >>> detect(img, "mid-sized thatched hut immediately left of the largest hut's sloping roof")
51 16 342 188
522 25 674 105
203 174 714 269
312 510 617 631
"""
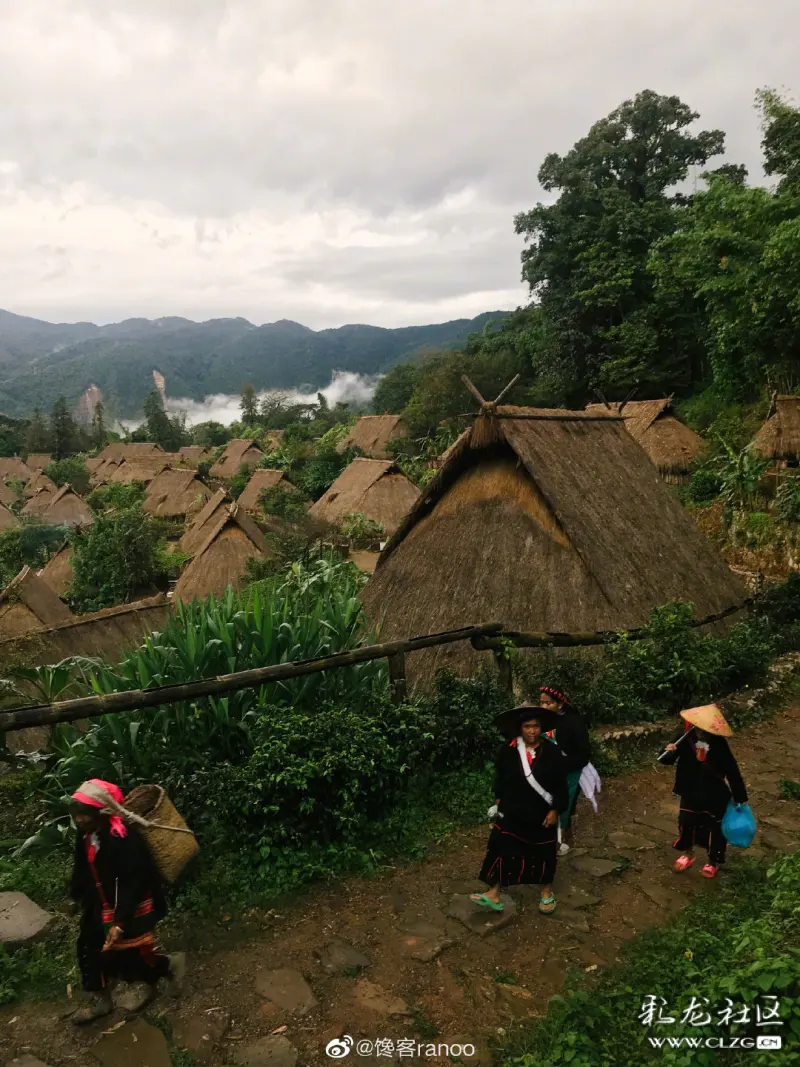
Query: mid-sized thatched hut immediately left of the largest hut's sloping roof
308 457 419 535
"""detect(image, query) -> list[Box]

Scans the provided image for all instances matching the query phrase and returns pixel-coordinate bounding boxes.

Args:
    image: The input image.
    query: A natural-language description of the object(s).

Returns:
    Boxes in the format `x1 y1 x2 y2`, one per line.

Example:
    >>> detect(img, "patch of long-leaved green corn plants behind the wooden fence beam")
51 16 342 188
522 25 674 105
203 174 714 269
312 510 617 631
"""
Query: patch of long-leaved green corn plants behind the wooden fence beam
40 559 387 794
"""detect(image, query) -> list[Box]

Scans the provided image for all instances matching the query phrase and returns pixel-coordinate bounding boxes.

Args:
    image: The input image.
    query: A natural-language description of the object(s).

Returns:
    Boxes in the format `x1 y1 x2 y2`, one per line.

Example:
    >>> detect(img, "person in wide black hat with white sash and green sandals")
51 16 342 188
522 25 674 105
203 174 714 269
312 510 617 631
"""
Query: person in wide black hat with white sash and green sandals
471 704 569 914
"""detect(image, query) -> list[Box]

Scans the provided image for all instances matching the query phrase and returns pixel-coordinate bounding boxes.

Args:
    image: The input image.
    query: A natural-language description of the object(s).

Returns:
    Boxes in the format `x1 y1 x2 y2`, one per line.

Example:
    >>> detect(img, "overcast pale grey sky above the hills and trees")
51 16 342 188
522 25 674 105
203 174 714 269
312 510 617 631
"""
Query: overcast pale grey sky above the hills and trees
0 0 800 328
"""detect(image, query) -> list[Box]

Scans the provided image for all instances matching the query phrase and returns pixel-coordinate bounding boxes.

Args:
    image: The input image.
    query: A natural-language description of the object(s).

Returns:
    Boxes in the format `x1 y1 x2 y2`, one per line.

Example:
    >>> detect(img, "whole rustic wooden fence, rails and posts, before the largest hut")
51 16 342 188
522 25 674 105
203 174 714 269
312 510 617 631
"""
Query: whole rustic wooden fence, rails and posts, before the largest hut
0 600 751 734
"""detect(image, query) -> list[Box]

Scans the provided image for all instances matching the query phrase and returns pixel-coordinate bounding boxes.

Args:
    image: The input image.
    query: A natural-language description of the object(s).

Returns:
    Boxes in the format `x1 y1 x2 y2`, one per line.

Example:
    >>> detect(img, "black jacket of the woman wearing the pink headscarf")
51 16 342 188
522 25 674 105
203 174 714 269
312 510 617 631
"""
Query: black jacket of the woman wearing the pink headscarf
69 827 166 937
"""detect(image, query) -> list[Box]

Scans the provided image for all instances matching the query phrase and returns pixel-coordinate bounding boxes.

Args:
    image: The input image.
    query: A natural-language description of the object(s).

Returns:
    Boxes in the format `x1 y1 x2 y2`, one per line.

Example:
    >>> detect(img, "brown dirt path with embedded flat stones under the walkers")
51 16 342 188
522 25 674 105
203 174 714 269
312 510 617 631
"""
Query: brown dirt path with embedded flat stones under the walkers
0 705 800 1067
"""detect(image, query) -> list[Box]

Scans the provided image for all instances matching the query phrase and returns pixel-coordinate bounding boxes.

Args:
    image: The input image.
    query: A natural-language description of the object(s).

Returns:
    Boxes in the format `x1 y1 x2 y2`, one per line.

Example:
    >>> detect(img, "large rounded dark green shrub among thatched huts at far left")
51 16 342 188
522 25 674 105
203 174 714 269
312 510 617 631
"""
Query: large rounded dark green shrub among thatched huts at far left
69 507 170 611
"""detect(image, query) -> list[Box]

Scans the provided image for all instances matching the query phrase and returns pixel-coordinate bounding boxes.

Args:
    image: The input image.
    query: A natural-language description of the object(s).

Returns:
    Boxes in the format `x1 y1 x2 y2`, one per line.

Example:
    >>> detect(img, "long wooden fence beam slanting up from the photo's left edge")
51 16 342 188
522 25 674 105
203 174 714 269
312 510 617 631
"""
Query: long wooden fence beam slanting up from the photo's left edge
0 622 502 733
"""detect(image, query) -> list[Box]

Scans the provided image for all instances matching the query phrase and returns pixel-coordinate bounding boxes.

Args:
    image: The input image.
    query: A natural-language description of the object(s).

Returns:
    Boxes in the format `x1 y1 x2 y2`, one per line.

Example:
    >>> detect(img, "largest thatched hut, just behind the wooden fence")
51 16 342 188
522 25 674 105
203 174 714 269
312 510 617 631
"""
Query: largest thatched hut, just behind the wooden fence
363 407 747 676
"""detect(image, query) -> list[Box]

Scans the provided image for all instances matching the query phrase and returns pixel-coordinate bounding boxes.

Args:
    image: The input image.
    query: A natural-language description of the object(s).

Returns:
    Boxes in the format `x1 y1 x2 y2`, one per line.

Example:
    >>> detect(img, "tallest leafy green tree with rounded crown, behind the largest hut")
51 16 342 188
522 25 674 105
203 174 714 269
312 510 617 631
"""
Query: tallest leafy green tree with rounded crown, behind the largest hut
515 90 724 403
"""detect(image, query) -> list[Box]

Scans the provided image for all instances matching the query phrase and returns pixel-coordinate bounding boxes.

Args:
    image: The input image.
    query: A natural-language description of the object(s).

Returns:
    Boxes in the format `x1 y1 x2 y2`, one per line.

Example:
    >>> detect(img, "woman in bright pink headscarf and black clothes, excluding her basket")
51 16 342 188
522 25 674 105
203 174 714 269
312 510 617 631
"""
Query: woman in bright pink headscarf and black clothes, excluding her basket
69 778 175 1025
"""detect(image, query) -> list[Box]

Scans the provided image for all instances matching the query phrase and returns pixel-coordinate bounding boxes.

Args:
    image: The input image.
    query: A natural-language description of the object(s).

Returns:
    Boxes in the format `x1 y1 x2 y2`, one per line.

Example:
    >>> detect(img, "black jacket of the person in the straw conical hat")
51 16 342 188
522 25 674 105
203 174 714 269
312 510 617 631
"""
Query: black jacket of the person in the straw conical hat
661 730 748 815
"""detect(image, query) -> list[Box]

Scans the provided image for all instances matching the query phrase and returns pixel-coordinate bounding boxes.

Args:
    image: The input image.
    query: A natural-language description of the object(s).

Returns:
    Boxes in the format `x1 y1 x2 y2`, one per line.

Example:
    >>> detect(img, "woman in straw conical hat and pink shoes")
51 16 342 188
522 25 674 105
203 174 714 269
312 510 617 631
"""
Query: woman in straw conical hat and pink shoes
660 704 748 878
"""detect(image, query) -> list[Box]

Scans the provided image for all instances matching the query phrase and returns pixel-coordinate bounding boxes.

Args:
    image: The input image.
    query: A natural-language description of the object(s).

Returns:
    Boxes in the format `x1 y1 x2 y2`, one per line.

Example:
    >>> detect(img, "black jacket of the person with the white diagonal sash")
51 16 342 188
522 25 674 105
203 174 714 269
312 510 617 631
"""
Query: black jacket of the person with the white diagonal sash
494 738 570 828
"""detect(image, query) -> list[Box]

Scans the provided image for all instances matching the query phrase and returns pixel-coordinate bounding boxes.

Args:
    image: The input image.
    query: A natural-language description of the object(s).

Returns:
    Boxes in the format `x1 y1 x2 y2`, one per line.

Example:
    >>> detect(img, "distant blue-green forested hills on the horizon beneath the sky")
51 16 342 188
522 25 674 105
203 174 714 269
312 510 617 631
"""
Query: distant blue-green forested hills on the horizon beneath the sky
0 310 507 417
